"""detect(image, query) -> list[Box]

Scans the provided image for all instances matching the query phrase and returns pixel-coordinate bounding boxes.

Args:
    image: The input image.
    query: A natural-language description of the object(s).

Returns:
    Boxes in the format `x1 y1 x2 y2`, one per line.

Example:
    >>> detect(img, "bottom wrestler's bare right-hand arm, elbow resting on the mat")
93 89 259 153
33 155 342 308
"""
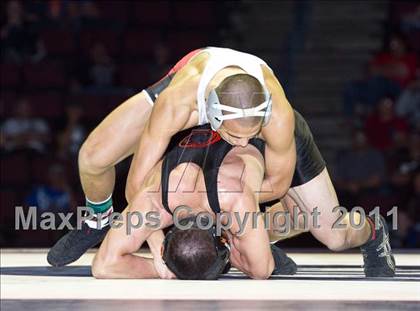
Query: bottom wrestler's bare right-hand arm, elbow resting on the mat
219 155 274 279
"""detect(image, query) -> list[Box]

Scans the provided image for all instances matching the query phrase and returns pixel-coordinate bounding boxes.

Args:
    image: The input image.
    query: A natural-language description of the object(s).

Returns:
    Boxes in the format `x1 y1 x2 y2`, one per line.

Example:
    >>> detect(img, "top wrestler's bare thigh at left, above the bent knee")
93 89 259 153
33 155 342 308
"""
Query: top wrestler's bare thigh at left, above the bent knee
84 93 152 166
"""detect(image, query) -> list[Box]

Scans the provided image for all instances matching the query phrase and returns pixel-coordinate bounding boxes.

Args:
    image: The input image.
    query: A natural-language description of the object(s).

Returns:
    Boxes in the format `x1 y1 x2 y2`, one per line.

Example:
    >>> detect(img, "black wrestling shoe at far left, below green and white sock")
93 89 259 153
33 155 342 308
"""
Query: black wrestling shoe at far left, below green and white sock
47 223 109 267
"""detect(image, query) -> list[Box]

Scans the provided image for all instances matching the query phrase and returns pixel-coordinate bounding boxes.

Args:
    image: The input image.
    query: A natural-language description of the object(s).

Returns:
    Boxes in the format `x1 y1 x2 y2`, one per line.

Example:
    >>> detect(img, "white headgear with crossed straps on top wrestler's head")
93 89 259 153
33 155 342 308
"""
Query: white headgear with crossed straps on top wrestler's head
206 88 272 131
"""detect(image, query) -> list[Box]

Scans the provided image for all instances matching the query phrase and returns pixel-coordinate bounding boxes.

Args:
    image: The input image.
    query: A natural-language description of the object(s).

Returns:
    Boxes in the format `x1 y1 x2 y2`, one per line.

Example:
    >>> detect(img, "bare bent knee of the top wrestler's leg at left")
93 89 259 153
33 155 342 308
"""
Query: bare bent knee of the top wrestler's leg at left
78 136 109 175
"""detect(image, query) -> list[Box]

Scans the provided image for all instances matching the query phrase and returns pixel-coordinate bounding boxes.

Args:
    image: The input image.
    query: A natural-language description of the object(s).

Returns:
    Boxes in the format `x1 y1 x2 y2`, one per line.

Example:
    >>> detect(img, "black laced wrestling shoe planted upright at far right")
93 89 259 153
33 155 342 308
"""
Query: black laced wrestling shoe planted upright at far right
360 216 395 277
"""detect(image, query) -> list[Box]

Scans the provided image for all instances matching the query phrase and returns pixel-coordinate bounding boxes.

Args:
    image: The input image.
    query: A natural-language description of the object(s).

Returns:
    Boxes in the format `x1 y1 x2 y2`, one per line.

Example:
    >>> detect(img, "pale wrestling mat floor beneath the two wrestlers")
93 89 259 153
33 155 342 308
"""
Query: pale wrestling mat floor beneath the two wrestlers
1 249 420 311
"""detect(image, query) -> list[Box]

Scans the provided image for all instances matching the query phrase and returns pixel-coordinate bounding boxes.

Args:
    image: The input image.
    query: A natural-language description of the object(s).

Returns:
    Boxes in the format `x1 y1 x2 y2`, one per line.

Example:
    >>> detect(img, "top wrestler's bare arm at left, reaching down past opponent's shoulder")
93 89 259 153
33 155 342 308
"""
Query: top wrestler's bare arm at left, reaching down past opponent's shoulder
126 65 198 201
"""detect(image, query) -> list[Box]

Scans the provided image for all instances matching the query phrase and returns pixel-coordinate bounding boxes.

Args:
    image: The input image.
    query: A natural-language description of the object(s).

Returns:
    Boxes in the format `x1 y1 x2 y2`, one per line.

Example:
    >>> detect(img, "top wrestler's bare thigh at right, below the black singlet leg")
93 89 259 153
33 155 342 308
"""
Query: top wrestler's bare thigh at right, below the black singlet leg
288 168 340 241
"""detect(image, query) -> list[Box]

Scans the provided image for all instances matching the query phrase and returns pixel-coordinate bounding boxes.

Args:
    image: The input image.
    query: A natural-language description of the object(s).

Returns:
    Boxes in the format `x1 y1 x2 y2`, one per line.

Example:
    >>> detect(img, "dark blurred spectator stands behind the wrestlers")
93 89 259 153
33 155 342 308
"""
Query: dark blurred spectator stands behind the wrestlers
0 0 420 248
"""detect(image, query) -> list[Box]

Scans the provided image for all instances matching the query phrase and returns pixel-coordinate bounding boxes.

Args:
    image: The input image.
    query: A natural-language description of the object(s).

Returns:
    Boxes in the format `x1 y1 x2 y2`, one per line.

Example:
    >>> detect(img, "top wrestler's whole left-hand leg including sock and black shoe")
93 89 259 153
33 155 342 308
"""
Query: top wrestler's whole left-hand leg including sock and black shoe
47 93 152 266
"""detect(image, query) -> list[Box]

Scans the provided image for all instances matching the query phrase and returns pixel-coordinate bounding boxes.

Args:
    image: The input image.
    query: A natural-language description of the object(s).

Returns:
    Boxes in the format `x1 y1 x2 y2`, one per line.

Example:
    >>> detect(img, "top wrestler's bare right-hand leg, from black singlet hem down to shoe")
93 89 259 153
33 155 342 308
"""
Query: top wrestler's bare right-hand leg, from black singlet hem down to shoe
288 168 371 251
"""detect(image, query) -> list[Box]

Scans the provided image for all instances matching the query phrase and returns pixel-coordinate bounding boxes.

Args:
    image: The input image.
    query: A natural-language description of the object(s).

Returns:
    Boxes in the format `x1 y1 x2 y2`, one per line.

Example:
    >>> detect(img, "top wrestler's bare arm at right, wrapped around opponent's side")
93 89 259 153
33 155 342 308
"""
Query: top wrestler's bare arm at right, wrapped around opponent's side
260 69 296 202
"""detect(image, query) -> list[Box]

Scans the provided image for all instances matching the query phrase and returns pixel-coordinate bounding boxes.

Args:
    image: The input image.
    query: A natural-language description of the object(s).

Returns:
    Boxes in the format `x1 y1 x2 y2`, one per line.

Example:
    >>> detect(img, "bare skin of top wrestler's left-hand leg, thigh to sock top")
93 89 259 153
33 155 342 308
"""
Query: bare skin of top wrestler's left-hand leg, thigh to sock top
79 92 152 202
